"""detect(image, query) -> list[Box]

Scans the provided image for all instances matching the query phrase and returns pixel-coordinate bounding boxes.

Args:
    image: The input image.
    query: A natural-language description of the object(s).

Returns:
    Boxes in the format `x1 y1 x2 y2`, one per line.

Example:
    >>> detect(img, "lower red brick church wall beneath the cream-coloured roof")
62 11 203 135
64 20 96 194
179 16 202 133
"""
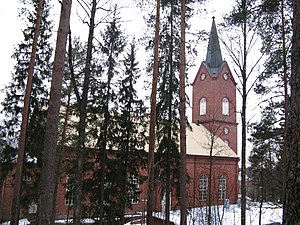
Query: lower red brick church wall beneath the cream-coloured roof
0 155 238 221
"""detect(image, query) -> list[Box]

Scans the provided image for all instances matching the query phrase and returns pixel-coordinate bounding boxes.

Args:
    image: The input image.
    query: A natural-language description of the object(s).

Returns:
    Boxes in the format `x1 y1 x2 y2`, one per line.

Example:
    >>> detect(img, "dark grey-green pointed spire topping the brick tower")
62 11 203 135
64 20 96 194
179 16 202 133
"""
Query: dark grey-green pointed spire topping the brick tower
205 17 223 76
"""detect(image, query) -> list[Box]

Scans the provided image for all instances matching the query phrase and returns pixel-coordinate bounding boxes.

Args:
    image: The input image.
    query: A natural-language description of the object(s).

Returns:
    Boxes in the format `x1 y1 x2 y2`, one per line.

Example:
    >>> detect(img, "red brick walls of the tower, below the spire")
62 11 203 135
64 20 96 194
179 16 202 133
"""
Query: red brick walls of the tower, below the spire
192 62 237 153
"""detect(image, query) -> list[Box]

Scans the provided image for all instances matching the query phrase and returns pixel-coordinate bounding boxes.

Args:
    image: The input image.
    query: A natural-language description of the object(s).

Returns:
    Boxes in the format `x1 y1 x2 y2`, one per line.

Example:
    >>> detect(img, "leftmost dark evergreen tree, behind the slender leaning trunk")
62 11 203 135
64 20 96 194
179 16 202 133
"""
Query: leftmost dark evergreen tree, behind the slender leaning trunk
1 0 52 220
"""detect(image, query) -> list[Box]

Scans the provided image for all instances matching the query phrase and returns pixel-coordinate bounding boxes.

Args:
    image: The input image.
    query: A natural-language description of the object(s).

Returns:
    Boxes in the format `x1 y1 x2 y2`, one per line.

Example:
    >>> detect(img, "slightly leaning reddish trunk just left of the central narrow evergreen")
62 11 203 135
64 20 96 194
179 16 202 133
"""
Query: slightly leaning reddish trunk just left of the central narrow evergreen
147 0 160 225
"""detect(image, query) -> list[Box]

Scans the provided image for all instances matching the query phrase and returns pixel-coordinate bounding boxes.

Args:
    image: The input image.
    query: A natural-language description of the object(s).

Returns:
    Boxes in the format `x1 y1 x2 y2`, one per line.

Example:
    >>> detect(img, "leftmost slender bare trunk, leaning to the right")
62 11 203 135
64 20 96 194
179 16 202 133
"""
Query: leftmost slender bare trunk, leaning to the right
10 0 44 225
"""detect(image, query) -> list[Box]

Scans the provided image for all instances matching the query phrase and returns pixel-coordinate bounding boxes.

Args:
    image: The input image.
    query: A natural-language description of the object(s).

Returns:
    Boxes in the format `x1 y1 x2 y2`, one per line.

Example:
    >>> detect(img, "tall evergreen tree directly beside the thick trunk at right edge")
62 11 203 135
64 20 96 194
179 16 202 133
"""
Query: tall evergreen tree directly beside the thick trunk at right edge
251 1 292 207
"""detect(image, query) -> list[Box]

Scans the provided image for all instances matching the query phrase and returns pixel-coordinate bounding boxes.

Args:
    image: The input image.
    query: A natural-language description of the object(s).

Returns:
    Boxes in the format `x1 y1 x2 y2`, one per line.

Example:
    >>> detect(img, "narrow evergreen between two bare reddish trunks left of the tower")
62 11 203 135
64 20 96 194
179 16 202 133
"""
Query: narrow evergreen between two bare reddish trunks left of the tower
156 1 180 221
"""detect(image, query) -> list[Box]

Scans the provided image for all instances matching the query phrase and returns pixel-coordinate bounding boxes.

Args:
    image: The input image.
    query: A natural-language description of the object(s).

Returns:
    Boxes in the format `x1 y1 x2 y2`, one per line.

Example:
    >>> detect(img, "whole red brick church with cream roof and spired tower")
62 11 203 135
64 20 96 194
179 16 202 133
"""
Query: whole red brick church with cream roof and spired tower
0 18 239 221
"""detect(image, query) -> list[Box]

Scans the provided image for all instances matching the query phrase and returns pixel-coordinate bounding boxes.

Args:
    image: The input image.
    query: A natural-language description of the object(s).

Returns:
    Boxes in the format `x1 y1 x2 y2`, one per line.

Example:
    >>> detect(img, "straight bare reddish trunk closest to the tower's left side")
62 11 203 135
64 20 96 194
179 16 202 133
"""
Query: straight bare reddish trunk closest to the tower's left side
179 0 187 225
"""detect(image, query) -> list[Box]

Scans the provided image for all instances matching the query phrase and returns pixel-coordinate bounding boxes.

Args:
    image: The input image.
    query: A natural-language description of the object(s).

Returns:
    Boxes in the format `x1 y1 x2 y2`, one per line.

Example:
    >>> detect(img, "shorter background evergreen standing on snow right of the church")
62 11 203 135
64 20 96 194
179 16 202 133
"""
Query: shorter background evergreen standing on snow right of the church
249 100 284 202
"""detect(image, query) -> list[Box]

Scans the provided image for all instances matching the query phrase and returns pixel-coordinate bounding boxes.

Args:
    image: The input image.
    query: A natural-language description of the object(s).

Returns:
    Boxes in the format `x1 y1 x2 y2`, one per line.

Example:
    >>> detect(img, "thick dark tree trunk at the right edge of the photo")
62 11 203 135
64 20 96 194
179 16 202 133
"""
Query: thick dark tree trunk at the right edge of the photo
283 0 300 225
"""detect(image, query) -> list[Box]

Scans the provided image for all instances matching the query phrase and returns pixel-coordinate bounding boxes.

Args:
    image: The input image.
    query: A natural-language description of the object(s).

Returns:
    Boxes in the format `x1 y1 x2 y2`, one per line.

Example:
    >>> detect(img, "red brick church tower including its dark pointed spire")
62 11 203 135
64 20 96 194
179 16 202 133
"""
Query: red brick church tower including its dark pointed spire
192 17 237 153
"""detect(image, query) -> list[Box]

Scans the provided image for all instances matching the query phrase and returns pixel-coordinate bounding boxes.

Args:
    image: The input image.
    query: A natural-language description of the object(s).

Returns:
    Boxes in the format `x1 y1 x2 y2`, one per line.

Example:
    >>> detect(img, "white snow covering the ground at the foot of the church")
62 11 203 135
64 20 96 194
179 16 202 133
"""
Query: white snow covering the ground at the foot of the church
2 203 282 225
